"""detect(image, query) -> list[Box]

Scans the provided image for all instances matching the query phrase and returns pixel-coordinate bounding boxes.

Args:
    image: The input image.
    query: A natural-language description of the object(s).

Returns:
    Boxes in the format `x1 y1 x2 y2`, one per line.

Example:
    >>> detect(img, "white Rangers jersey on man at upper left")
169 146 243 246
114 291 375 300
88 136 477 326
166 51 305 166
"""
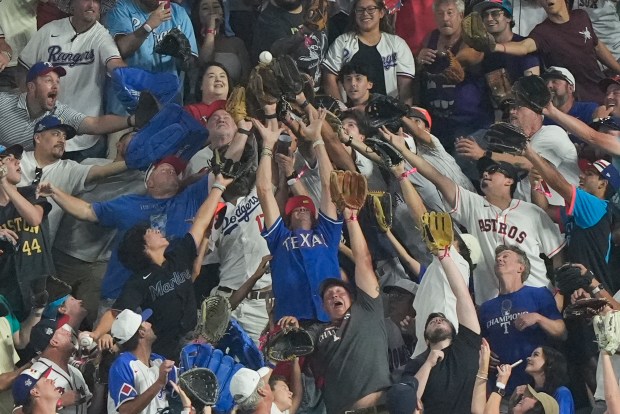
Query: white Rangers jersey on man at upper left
19 17 121 151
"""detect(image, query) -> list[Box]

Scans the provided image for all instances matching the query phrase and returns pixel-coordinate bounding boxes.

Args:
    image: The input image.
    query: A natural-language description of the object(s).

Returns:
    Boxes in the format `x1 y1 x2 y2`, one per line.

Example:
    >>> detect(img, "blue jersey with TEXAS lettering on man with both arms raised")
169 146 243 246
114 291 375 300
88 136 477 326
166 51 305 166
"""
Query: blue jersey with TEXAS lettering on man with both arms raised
262 212 342 322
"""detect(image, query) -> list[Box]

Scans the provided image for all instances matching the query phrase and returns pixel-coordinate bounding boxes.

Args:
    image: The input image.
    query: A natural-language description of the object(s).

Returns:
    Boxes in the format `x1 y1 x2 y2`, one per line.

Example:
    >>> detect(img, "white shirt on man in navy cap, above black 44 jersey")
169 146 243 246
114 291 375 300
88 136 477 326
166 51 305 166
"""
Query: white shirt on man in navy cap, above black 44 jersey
18 151 93 243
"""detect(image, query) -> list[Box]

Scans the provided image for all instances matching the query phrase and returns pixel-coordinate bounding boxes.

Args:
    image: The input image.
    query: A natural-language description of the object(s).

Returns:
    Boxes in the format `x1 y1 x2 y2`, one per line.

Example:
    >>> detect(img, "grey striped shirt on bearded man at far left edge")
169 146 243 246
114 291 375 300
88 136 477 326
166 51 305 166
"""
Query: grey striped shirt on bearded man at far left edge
0 92 86 151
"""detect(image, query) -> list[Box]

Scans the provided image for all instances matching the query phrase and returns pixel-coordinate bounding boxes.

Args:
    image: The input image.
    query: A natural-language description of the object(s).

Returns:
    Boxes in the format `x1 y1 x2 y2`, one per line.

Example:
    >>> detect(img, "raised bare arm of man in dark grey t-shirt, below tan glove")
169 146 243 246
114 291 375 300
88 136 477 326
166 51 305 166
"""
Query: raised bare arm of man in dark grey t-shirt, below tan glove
344 207 379 298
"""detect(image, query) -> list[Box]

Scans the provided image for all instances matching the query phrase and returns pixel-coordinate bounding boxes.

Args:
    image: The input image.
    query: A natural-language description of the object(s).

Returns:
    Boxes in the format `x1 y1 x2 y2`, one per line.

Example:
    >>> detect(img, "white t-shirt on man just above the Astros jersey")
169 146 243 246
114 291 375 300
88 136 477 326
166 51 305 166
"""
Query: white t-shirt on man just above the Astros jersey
514 125 579 206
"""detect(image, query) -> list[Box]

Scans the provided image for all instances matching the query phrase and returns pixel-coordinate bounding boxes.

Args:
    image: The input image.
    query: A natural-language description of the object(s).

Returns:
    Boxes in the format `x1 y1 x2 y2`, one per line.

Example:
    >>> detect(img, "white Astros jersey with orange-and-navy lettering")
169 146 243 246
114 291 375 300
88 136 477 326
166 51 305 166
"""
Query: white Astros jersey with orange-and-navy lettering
450 186 565 304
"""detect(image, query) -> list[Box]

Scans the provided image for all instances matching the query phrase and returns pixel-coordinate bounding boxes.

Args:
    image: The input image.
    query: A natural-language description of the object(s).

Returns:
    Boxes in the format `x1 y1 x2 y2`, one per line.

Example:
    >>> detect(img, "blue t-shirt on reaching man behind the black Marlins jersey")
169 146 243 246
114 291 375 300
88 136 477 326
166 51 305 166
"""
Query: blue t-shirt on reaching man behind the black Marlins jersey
93 176 209 299
